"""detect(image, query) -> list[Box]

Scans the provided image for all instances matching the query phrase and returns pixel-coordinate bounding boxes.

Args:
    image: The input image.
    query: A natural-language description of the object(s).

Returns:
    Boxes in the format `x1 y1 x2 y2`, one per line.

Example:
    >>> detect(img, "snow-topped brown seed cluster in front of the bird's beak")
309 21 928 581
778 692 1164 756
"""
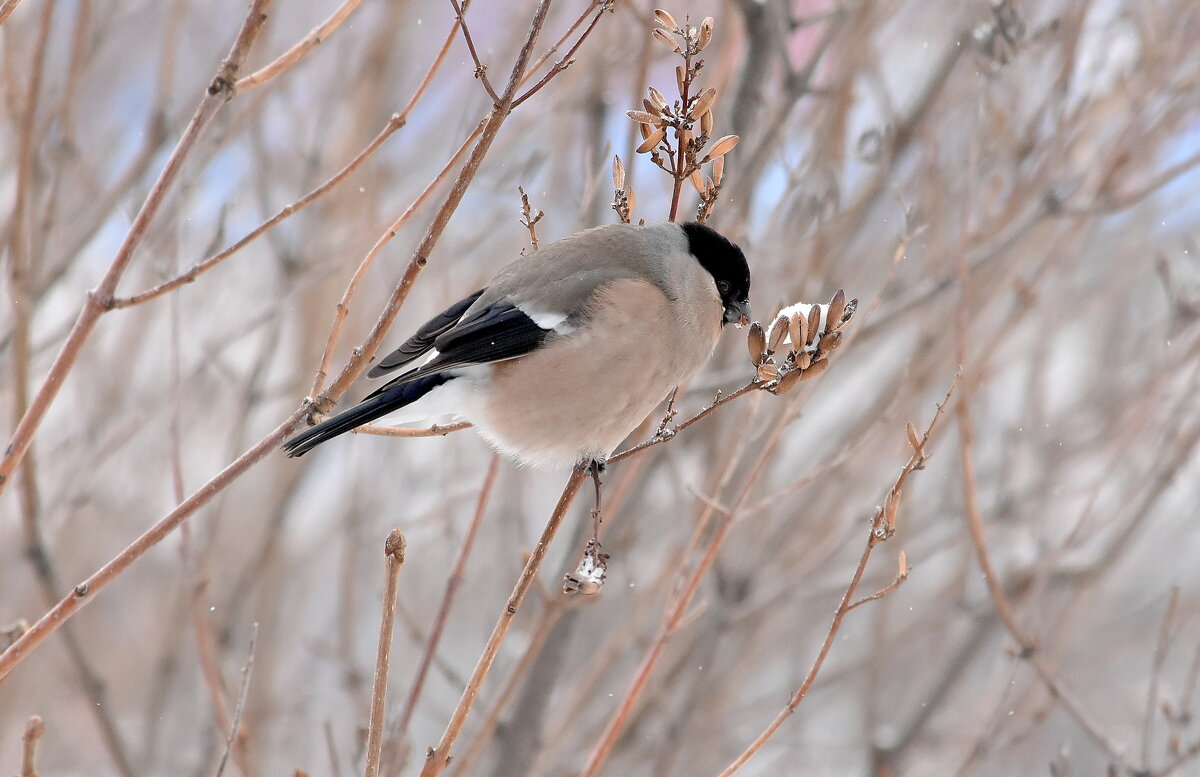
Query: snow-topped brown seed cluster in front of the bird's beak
746 289 858 394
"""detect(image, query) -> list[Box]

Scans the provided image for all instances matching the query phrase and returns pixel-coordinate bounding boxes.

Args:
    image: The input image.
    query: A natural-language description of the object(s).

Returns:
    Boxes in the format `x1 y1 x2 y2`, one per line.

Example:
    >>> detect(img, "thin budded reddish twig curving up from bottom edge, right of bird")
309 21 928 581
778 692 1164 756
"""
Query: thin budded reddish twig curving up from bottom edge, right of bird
720 375 959 777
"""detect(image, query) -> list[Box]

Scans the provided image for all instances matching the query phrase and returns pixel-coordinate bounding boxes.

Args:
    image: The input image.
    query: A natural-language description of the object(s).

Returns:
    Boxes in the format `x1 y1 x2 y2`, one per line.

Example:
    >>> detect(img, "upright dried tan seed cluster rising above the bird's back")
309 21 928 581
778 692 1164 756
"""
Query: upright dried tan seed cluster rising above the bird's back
613 8 739 223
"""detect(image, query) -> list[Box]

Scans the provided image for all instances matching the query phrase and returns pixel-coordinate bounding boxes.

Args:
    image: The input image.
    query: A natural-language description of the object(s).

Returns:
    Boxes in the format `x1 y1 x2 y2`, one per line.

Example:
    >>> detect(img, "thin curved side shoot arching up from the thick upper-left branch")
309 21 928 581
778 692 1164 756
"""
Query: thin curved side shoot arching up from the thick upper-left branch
110 7 458 308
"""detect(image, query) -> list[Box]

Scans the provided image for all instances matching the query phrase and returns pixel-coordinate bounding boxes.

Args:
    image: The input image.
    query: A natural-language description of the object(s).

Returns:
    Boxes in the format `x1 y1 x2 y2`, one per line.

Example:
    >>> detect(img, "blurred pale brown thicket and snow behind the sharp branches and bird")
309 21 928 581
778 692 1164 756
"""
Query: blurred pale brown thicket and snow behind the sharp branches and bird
0 0 1200 777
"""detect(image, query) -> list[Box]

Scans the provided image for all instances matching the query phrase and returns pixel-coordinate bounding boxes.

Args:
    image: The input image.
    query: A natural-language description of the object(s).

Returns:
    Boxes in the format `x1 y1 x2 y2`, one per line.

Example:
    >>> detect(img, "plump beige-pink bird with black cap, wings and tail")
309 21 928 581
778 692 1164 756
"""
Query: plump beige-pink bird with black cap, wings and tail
283 222 750 469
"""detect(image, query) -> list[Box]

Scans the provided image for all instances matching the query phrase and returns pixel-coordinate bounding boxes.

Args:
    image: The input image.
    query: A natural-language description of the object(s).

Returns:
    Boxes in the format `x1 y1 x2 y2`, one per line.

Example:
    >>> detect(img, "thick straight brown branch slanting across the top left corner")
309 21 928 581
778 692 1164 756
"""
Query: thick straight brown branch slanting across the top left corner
0 0 270 498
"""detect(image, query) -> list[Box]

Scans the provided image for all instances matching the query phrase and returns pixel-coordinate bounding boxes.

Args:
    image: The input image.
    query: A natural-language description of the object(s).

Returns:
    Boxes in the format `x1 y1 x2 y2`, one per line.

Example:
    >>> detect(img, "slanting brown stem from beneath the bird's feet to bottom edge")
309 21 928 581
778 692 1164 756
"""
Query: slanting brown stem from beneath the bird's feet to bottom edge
421 468 588 777
